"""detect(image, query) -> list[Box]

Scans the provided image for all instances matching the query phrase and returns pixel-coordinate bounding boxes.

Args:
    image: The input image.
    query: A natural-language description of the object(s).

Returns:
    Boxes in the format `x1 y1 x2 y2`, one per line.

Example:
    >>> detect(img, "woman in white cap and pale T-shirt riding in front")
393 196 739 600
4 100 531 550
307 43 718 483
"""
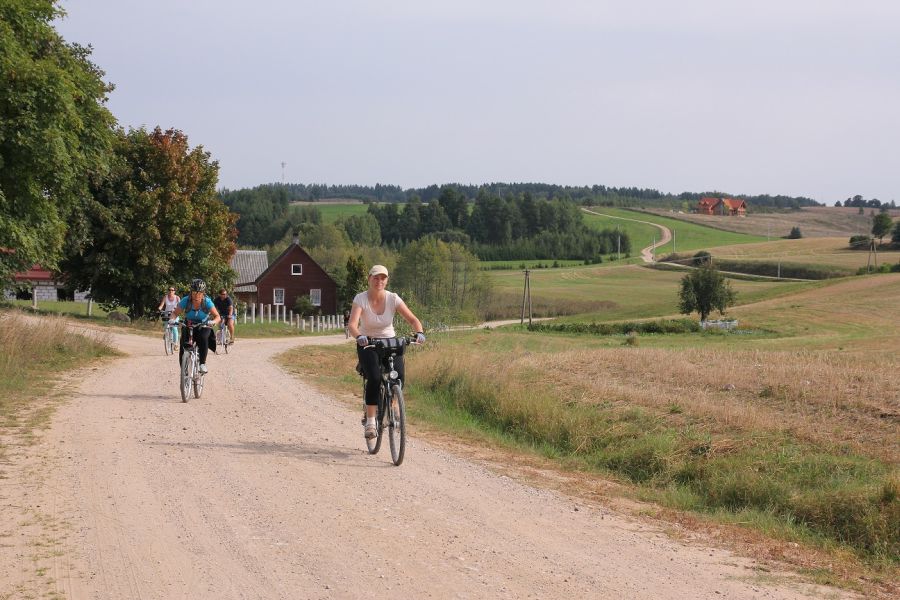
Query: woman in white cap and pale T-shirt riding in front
348 265 425 439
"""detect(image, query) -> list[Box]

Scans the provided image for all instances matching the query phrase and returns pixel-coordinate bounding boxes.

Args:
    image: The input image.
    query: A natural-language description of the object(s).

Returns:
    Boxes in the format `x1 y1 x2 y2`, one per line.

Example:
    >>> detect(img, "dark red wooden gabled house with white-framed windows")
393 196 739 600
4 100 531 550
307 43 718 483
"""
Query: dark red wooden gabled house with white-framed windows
256 237 338 315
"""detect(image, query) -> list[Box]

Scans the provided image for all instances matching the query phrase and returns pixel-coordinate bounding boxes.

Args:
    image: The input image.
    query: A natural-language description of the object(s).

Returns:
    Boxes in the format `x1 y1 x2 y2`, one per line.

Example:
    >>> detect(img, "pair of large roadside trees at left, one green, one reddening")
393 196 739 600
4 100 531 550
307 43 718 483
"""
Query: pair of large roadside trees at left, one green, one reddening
0 0 236 316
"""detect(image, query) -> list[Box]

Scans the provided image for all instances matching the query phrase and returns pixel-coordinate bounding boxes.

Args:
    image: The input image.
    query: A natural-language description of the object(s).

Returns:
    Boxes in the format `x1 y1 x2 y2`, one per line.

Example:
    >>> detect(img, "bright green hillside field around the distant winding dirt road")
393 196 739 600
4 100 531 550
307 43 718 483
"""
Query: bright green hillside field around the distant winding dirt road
584 207 766 255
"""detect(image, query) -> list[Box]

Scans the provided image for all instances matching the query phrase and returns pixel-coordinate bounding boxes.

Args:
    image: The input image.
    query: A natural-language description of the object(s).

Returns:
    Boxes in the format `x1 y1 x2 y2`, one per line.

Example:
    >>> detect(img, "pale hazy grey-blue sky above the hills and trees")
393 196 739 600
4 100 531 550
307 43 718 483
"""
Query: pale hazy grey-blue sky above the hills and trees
56 0 900 205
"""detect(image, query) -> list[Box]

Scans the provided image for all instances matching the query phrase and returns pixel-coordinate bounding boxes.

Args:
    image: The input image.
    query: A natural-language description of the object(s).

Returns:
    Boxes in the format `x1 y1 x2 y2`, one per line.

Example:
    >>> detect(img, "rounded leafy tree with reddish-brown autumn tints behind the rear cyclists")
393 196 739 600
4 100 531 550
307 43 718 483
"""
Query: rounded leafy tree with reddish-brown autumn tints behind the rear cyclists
63 127 237 316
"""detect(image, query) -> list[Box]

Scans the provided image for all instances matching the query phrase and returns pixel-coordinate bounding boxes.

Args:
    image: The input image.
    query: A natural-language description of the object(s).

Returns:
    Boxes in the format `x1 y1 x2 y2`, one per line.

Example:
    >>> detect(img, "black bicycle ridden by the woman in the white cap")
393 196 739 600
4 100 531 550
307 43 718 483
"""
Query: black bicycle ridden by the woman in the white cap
356 338 416 467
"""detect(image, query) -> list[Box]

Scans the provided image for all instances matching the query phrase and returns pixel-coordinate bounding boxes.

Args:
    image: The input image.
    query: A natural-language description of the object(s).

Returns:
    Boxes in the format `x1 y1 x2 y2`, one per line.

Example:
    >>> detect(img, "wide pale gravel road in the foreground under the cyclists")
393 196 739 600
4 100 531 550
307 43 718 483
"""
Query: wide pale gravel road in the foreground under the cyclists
0 326 845 600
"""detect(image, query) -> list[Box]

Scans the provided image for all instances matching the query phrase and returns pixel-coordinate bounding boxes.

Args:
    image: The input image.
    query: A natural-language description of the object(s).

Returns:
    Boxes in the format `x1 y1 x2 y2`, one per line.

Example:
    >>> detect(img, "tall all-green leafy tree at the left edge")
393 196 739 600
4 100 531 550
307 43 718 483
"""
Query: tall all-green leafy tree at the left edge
0 0 115 287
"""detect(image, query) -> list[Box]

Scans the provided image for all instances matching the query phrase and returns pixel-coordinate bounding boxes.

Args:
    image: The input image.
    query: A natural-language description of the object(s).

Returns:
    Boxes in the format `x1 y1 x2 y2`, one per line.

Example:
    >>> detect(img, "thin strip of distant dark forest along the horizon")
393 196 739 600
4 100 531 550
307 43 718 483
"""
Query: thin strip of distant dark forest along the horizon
220 182 821 209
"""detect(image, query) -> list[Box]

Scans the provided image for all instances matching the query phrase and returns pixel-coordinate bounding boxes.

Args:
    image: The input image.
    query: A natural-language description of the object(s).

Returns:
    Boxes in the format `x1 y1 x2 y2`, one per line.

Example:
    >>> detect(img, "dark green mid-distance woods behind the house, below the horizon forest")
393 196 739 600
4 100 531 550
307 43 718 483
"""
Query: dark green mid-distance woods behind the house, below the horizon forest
219 185 631 262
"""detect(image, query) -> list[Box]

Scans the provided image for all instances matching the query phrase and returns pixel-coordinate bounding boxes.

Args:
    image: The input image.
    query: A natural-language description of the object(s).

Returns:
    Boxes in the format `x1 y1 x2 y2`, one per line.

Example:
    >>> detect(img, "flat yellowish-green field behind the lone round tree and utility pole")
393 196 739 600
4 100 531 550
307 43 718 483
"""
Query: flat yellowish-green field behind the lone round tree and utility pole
480 265 818 321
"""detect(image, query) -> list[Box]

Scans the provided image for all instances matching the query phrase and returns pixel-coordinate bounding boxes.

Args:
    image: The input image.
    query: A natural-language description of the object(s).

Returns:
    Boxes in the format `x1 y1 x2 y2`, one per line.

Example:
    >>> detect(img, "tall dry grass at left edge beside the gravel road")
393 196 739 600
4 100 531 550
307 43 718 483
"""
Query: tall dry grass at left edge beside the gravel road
0 311 116 458
